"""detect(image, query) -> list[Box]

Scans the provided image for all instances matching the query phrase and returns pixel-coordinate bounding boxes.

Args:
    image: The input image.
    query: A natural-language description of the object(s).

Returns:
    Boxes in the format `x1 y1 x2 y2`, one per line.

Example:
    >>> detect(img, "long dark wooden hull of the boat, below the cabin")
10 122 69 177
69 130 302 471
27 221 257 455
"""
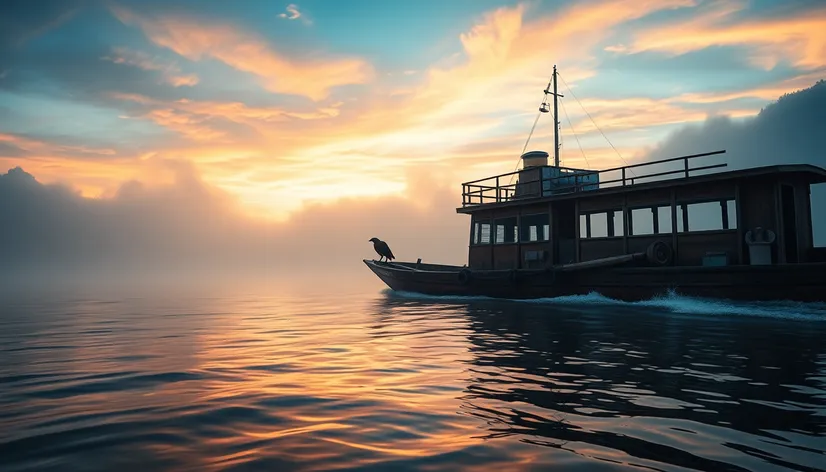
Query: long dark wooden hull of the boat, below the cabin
364 259 826 302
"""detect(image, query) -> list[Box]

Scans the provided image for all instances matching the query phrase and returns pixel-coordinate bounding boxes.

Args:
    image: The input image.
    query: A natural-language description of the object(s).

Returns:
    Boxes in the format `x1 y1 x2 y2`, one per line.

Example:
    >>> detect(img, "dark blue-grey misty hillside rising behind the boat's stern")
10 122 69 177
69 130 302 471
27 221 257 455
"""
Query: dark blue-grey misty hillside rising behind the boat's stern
643 80 826 246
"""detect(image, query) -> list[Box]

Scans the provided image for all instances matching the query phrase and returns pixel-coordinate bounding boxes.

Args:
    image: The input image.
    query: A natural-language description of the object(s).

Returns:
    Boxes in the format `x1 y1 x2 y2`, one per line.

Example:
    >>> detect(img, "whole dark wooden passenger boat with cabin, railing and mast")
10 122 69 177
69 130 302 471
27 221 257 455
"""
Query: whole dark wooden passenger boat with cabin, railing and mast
363 66 826 302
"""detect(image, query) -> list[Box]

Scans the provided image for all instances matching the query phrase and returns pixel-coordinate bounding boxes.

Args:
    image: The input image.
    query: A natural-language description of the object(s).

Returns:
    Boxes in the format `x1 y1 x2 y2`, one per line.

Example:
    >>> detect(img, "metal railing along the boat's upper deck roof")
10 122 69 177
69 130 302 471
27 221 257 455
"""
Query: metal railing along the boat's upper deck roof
462 150 727 207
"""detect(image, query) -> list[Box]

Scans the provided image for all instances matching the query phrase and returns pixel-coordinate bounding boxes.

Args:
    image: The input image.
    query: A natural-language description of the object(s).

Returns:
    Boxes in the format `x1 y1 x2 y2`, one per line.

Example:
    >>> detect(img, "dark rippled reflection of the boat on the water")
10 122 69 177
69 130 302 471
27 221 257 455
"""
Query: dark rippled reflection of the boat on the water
377 296 826 471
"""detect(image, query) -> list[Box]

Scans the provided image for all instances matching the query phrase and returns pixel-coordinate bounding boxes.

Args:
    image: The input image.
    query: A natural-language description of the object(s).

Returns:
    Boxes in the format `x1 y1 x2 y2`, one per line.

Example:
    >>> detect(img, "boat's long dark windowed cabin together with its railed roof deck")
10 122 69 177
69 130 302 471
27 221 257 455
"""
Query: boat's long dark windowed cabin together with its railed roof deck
457 151 826 269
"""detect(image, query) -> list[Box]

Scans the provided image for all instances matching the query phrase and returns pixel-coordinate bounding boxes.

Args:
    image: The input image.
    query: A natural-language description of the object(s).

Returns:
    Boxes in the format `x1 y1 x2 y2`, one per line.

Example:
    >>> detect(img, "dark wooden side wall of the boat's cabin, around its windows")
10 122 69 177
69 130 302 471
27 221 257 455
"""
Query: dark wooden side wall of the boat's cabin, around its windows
468 170 815 269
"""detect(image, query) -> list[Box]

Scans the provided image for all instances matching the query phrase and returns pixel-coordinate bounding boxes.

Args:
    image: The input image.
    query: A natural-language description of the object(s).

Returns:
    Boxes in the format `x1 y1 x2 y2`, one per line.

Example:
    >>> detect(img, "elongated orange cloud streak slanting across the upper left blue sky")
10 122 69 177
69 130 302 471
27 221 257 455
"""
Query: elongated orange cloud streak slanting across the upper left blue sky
112 7 374 101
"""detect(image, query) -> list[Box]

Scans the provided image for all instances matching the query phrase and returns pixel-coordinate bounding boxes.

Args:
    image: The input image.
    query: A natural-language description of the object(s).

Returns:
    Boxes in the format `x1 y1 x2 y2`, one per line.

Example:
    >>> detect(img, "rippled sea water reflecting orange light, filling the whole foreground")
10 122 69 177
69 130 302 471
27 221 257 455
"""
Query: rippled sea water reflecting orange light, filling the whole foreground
0 276 826 472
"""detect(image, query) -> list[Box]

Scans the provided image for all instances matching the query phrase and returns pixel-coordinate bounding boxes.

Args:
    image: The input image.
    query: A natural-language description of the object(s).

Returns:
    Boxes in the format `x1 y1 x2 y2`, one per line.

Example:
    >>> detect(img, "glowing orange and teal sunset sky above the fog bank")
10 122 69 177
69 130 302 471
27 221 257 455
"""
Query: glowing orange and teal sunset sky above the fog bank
0 0 826 223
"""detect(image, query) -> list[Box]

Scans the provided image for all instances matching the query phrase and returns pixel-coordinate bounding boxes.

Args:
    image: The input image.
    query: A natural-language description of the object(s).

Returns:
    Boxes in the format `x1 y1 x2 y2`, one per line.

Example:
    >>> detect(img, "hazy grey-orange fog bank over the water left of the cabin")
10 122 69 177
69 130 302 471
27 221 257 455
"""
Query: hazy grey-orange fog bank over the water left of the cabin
0 160 468 290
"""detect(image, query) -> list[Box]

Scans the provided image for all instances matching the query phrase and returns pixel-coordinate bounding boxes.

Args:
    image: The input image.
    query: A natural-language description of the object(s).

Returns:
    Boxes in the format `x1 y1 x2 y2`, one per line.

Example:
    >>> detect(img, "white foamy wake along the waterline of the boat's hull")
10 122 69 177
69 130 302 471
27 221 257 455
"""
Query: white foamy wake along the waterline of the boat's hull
383 289 826 322
